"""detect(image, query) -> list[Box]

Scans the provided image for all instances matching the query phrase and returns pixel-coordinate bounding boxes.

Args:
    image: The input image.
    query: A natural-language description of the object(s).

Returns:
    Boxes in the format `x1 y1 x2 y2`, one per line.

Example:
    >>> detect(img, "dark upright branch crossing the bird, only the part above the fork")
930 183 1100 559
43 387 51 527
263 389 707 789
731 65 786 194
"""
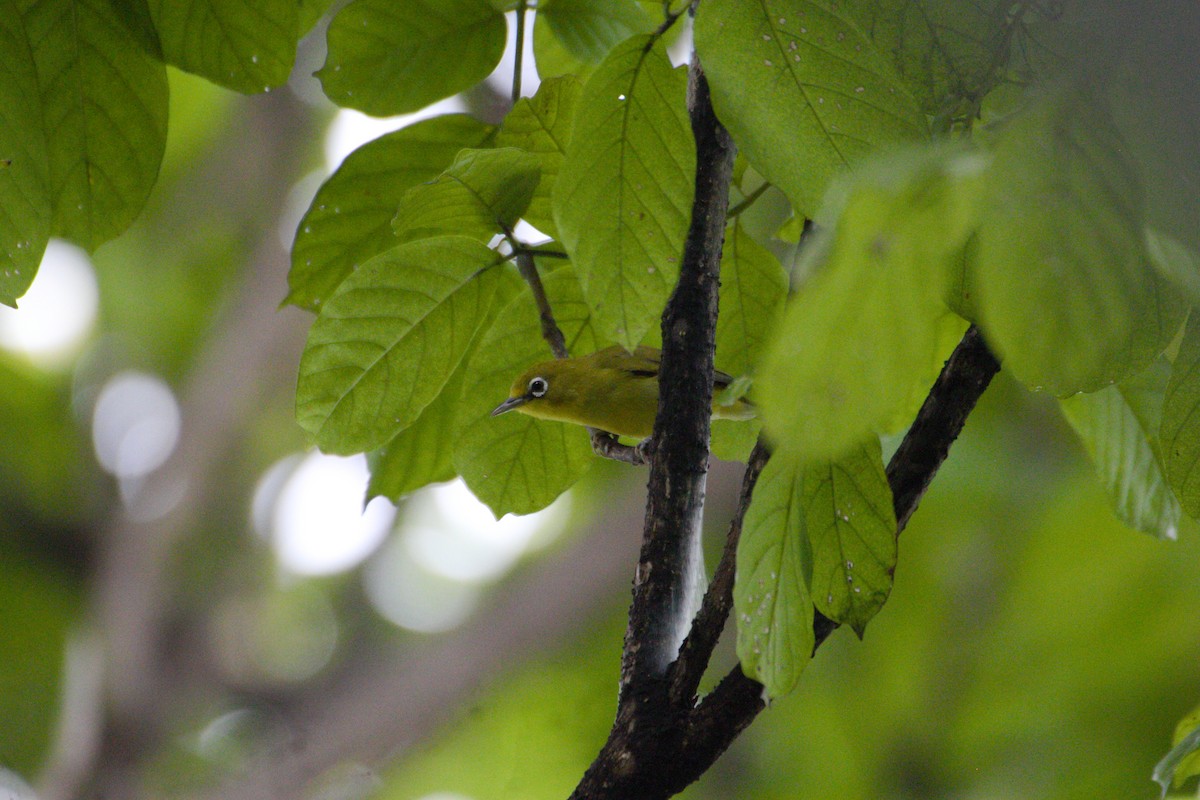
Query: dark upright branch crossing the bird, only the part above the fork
622 56 734 690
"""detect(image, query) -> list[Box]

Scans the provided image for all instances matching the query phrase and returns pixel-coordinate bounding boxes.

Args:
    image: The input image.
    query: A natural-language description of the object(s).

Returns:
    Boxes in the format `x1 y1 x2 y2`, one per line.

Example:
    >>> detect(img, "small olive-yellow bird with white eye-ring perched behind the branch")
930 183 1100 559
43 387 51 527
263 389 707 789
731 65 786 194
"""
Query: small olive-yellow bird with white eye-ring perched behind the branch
492 345 755 439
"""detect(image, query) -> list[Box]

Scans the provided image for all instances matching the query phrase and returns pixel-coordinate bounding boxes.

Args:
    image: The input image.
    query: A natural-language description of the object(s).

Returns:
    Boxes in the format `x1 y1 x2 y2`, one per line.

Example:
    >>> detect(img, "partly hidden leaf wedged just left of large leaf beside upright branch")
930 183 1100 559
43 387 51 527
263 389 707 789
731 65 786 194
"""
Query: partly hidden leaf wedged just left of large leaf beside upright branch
496 76 583 239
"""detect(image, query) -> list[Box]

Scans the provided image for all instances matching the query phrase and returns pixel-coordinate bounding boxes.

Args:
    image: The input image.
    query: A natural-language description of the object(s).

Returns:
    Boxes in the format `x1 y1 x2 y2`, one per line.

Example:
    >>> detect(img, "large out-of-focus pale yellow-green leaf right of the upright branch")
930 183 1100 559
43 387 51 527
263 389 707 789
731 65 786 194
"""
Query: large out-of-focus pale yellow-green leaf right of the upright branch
756 148 979 461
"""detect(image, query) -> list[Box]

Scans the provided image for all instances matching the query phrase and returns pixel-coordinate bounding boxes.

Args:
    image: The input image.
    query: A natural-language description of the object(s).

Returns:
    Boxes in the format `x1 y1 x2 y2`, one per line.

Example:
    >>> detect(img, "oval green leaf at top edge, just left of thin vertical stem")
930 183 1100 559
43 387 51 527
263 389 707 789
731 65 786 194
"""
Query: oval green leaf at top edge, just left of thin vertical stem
317 0 506 116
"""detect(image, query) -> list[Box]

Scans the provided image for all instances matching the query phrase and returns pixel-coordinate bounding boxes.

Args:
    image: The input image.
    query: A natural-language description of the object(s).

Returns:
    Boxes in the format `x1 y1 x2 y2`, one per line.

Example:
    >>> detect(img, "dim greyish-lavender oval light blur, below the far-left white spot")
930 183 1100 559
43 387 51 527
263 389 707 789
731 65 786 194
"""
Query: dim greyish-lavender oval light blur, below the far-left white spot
91 371 180 479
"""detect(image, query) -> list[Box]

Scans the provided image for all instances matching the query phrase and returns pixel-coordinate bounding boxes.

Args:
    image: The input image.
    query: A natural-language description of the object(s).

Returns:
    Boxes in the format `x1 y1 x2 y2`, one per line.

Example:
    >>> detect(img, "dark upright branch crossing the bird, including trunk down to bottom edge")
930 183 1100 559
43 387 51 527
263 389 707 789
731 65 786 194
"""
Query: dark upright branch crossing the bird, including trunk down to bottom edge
572 55 734 798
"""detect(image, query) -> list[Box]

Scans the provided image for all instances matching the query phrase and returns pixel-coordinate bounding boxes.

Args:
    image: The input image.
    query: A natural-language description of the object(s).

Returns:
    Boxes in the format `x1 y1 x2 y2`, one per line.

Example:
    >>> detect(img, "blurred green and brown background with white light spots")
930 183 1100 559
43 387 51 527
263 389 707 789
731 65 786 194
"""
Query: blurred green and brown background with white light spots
0 10 1200 800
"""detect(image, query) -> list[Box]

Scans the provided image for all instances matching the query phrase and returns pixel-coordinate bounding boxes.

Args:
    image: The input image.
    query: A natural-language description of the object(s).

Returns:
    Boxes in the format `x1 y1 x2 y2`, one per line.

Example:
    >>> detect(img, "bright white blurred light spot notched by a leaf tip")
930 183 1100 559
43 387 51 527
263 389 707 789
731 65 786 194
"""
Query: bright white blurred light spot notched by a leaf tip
267 451 395 575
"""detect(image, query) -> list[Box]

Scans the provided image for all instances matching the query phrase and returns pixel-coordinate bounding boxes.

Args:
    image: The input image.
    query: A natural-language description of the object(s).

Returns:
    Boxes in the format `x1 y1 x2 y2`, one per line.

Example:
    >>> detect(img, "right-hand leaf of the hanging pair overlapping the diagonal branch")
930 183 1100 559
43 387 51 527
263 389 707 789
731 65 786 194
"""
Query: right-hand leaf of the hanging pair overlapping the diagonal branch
802 437 896 637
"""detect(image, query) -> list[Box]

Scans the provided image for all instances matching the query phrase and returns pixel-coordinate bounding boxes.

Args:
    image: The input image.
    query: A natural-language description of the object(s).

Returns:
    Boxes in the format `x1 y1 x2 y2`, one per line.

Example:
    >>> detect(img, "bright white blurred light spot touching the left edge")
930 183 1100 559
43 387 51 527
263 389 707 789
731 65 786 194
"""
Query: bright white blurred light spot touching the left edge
0 239 100 363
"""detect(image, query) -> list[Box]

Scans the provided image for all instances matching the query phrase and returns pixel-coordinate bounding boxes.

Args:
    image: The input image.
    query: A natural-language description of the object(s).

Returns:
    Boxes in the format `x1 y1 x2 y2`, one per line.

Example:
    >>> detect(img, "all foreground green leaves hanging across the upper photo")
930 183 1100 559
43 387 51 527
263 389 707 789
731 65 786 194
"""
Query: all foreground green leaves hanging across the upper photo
0 0 1200 714
